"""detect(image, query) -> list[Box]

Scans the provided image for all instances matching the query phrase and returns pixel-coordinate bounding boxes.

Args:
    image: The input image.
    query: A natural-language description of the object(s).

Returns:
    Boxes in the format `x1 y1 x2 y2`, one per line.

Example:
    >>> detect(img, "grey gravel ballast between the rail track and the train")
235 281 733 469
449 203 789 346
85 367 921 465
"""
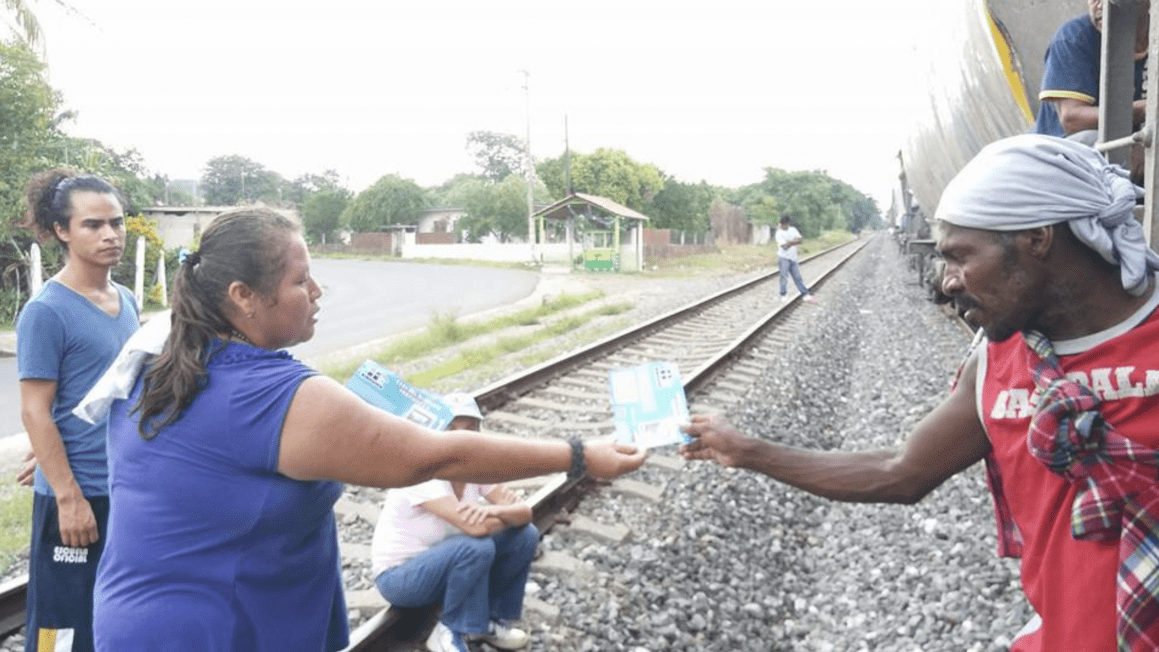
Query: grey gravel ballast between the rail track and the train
529 237 1030 652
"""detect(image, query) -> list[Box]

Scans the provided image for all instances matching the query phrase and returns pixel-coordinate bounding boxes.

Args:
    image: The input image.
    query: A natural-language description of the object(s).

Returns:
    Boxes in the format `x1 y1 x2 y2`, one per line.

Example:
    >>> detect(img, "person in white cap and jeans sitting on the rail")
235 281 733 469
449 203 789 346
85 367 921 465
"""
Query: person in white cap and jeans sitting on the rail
371 393 539 652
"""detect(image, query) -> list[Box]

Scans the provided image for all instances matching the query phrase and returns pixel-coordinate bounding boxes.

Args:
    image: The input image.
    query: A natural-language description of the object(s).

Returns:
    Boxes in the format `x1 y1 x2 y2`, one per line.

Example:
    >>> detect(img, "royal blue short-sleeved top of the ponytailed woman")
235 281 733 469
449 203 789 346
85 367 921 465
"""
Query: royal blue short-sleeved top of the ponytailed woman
93 340 349 652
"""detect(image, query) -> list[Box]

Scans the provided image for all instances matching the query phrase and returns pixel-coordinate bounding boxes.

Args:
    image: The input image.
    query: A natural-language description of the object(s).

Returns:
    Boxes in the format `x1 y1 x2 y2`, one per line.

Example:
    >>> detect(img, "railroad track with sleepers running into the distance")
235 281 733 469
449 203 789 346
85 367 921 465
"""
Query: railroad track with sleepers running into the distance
0 231 917 652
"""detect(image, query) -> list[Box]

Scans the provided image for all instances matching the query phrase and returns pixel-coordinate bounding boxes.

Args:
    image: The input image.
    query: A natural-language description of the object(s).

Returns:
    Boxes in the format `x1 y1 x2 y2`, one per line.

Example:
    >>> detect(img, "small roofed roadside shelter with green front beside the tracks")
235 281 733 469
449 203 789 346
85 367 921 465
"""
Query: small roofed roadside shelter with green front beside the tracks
534 192 648 271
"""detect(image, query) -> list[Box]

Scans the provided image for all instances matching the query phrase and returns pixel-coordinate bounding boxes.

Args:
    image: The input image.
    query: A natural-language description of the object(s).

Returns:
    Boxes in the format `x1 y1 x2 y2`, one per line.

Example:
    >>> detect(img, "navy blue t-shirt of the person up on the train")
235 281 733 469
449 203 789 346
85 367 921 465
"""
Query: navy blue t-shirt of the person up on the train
1034 14 1146 137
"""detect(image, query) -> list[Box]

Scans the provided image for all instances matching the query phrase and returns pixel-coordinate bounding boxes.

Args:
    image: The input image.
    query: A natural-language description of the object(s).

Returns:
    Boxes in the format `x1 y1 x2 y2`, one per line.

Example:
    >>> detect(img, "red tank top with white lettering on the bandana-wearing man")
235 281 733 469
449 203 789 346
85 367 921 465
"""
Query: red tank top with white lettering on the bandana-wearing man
977 303 1159 652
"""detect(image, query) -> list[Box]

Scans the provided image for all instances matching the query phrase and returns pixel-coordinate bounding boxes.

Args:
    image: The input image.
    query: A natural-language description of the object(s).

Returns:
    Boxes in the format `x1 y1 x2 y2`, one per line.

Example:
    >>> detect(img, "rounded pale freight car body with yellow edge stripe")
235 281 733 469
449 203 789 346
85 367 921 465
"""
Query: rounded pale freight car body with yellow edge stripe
890 0 1087 287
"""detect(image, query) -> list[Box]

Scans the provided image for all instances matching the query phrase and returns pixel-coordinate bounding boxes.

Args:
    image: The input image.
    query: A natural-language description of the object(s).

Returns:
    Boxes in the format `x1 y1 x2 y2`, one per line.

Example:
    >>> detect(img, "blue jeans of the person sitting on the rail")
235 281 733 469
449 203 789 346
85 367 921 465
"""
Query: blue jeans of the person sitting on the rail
374 523 539 633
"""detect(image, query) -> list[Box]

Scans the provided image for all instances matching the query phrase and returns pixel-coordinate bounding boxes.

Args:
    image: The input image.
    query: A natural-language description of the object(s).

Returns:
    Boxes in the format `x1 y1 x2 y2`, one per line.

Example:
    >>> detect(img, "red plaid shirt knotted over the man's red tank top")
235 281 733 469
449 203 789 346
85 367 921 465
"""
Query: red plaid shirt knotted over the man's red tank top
986 331 1159 652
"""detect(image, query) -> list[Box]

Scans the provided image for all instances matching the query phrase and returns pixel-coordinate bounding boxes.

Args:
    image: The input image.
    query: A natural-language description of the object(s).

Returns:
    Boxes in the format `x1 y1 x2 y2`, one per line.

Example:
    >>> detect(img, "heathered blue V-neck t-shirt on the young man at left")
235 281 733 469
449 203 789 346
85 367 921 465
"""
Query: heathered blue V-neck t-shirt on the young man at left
16 280 139 496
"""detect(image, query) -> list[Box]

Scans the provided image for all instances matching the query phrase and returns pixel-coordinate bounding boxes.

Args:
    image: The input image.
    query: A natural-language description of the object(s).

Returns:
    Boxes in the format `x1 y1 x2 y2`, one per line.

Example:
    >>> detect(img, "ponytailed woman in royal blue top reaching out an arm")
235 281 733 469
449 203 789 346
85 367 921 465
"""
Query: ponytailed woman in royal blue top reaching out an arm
84 207 644 652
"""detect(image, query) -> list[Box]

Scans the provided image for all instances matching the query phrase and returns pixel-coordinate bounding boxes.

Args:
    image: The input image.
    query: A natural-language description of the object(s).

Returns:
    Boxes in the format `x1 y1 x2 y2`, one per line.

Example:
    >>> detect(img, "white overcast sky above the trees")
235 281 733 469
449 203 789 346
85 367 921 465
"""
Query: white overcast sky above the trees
34 0 939 210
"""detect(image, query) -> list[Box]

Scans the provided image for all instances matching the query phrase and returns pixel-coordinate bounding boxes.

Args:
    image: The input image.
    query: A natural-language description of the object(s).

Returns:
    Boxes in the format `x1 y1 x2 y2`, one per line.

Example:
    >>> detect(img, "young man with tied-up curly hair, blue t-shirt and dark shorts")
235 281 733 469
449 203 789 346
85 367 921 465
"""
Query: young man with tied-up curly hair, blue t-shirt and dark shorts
16 169 138 652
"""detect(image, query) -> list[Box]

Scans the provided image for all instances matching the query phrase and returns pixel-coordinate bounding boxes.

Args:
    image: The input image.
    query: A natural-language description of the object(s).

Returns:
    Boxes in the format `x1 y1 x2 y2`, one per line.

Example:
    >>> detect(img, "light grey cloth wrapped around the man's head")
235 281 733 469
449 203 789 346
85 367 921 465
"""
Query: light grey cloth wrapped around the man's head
935 134 1159 296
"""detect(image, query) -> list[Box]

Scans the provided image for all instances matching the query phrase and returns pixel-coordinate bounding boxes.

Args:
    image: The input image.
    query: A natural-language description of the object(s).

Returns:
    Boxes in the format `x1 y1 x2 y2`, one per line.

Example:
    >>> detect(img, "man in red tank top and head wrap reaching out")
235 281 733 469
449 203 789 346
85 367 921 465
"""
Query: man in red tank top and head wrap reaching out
683 134 1159 652
